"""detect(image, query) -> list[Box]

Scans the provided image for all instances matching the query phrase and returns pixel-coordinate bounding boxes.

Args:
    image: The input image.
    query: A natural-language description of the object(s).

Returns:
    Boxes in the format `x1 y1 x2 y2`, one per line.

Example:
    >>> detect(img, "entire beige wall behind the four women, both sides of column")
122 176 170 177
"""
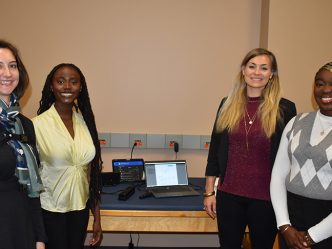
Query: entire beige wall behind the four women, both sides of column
1 0 332 247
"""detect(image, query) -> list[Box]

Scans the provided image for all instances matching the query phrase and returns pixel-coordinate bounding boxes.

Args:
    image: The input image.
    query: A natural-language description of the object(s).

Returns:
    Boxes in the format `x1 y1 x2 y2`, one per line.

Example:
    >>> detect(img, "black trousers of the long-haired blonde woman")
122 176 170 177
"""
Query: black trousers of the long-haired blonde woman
217 191 277 249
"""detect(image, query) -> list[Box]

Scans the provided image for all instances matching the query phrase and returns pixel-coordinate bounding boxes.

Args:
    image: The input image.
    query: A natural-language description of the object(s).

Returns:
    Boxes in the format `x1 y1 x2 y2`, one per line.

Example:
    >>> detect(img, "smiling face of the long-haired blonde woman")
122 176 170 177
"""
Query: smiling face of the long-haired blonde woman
242 55 273 97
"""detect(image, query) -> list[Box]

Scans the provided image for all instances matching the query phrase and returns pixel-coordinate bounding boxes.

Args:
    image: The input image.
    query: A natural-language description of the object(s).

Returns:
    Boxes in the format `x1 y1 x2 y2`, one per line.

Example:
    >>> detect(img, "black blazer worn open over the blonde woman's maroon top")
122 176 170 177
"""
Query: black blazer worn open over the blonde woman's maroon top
205 98 296 181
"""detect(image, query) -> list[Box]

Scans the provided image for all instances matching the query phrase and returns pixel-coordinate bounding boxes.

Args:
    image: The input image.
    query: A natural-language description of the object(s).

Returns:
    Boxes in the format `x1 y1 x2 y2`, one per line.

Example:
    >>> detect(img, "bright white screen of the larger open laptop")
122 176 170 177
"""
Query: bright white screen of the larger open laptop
145 160 188 187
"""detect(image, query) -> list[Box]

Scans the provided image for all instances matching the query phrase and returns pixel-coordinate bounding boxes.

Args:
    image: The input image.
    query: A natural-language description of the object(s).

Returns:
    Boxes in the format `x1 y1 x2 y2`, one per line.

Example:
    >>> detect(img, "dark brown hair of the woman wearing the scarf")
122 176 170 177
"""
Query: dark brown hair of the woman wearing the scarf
0 40 30 99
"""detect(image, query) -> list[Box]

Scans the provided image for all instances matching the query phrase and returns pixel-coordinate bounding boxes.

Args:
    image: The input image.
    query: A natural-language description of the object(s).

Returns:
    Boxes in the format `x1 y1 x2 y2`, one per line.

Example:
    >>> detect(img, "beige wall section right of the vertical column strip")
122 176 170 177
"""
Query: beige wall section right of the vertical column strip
268 0 332 112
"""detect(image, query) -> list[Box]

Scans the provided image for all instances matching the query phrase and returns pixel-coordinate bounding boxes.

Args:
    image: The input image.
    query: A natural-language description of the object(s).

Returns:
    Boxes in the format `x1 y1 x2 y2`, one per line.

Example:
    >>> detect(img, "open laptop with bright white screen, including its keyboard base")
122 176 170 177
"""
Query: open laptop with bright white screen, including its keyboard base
144 160 200 198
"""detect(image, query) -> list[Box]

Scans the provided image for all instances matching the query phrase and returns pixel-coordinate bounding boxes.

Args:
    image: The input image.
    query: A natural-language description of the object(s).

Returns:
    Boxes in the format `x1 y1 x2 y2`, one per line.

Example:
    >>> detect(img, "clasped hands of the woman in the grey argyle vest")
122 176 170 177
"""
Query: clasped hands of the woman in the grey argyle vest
281 226 311 249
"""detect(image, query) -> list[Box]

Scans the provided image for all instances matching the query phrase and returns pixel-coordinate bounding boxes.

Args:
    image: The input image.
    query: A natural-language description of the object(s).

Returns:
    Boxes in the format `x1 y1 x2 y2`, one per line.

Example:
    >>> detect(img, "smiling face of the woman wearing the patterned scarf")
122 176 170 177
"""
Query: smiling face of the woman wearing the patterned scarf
0 48 20 104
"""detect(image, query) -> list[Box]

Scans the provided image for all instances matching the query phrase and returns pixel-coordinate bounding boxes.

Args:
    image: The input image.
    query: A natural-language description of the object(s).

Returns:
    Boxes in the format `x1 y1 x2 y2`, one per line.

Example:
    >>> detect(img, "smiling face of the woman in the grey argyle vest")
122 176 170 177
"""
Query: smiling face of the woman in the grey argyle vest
314 69 332 116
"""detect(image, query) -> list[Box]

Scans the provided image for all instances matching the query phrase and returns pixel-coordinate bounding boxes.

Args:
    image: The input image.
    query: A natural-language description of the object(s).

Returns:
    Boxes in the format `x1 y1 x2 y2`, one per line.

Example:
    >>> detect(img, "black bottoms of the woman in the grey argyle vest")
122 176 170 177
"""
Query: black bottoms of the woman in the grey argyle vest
280 192 332 249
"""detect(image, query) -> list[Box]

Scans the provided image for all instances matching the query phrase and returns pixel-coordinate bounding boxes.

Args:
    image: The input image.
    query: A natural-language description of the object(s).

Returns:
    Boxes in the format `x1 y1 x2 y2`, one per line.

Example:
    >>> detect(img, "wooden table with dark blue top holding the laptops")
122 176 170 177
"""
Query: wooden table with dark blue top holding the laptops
88 178 218 233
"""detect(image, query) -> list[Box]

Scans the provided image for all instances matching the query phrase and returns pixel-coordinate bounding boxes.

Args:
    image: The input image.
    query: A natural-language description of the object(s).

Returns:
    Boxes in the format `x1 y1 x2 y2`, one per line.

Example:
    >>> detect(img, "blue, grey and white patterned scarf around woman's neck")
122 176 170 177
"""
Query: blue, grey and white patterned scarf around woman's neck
0 93 43 197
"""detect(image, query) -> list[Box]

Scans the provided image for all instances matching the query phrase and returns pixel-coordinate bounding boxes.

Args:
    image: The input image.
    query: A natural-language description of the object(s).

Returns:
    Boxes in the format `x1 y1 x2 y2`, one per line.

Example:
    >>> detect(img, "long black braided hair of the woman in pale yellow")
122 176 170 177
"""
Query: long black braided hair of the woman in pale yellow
37 63 103 208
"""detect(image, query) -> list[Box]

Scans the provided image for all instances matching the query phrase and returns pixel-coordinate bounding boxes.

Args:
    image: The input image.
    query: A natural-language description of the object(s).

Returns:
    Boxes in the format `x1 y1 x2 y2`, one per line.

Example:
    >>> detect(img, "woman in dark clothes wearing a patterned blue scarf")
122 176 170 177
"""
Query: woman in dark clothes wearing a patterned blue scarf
0 40 46 249
